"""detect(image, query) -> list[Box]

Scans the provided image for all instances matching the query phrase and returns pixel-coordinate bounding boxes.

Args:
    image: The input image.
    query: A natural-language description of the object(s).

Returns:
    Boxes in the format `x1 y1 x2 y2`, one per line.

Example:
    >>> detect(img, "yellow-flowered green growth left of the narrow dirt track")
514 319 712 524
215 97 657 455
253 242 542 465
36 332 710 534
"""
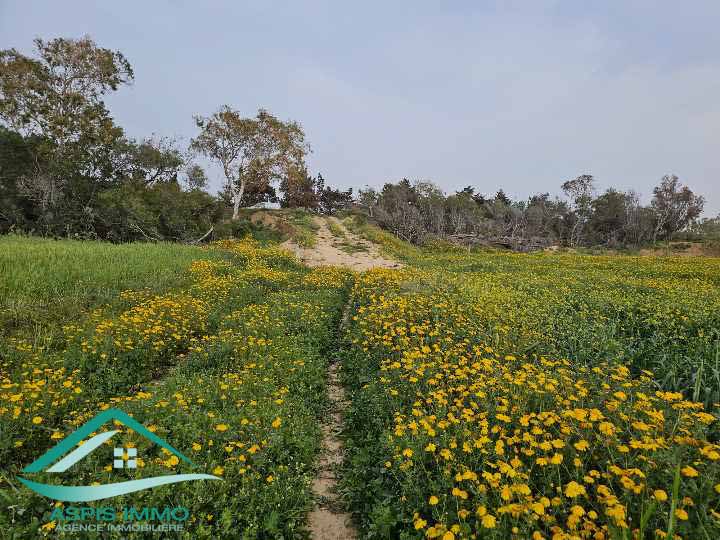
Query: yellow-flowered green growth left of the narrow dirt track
0 236 349 538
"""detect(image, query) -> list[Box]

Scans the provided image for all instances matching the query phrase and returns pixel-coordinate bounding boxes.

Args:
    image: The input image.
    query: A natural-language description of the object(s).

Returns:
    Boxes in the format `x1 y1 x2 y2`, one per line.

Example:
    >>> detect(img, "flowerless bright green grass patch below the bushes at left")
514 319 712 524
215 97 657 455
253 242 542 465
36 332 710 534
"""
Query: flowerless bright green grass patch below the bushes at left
0 235 226 342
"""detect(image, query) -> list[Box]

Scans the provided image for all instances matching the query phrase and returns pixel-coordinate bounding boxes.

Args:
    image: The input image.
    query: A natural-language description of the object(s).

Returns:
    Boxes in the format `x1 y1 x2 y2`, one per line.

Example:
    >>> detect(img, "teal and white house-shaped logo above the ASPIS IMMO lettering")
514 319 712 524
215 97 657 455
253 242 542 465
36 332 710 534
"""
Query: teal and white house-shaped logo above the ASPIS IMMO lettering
18 409 222 502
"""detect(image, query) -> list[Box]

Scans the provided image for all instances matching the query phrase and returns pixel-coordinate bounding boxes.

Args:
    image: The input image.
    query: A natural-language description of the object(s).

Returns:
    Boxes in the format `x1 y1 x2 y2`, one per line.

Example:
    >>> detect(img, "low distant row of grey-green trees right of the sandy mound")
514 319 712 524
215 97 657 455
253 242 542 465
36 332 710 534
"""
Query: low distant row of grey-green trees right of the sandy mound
357 175 704 248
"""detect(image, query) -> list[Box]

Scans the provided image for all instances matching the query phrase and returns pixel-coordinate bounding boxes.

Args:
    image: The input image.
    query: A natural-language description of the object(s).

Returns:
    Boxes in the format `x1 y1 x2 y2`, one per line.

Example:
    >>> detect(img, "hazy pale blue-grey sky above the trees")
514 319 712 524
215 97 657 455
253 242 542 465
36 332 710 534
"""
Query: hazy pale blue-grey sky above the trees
0 0 720 217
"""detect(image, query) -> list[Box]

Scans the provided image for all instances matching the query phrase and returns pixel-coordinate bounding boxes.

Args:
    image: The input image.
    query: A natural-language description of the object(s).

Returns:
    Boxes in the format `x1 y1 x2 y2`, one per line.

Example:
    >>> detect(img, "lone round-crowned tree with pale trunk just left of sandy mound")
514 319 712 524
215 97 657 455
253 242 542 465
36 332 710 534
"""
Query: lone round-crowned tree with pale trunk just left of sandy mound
190 106 309 219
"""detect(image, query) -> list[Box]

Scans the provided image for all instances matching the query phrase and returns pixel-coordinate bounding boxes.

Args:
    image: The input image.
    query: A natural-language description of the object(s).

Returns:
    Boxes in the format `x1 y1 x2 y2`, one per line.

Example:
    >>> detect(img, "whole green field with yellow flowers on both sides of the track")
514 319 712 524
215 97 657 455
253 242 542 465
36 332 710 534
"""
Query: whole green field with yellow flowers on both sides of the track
0 229 720 540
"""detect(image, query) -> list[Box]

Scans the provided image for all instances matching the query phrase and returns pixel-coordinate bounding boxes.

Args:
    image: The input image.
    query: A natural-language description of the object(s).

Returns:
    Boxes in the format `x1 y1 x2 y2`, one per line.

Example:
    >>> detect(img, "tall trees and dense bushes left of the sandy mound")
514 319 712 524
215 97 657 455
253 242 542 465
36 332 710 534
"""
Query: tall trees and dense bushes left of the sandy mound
0 37 350 241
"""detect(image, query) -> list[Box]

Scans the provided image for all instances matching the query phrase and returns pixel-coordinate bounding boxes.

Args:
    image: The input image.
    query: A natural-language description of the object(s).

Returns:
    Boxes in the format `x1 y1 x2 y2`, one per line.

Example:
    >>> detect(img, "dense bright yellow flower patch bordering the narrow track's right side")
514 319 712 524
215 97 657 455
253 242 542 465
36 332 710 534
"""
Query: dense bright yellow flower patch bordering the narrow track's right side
348 270 720 539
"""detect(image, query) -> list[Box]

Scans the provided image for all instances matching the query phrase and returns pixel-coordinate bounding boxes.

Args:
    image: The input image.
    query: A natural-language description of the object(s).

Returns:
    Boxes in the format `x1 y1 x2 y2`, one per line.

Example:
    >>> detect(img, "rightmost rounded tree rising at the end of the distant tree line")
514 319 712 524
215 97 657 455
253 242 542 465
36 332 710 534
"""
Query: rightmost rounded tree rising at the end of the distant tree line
651 174 705 241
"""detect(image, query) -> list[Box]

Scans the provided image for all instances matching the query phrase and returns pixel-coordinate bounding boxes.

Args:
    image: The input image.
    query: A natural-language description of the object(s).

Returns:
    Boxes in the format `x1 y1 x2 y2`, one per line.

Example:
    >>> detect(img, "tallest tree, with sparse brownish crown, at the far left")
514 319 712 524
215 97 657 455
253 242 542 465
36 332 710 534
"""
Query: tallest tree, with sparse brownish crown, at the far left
0 37 133 215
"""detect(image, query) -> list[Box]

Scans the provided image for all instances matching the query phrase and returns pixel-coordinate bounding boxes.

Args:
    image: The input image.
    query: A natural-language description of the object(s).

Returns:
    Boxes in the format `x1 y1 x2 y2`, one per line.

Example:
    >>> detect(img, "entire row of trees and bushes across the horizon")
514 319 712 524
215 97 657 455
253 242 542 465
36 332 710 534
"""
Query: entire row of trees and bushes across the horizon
0 37 720 247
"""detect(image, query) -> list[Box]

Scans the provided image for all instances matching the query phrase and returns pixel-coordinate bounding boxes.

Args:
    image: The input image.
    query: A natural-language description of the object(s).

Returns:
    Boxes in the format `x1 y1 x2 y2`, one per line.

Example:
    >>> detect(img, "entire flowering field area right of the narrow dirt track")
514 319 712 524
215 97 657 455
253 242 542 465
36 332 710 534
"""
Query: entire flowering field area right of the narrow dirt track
343 252 720 540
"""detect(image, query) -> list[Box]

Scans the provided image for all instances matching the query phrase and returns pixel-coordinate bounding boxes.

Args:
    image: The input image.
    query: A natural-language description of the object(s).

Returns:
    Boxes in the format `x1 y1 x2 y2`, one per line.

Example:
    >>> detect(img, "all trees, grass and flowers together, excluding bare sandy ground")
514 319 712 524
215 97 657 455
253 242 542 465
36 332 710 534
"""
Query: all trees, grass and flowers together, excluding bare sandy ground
0 29 720 540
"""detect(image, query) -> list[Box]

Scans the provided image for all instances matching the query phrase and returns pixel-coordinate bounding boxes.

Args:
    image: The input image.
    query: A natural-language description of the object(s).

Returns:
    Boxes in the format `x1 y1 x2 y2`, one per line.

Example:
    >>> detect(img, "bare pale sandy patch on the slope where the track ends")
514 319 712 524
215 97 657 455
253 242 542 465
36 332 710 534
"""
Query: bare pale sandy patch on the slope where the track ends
282 217 402 272
